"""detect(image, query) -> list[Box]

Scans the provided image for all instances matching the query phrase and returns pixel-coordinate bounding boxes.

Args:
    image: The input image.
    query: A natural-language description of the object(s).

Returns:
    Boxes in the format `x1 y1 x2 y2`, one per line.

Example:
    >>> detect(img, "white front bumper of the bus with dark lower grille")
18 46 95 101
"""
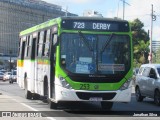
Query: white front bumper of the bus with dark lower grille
51 85 132 103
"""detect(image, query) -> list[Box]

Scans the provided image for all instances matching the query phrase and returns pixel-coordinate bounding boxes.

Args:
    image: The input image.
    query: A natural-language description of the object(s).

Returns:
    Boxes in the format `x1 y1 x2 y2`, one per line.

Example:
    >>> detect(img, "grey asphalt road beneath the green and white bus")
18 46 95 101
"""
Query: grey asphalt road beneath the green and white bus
0 81 160 120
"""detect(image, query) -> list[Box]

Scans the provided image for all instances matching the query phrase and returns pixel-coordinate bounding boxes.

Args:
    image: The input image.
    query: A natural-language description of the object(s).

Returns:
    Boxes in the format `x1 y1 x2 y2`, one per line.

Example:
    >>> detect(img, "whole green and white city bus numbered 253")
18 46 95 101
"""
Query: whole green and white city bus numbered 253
17 17 133 110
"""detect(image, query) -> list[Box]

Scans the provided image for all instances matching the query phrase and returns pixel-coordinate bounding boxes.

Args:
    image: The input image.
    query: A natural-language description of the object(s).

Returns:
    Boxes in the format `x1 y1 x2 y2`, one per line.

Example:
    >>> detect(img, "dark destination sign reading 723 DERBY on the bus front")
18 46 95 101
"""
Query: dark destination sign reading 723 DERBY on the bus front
62 20 129 32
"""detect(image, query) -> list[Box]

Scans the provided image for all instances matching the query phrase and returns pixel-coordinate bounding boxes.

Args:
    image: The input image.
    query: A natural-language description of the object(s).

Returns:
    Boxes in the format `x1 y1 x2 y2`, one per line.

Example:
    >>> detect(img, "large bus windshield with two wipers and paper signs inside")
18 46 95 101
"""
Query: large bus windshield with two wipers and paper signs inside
60 33 131 74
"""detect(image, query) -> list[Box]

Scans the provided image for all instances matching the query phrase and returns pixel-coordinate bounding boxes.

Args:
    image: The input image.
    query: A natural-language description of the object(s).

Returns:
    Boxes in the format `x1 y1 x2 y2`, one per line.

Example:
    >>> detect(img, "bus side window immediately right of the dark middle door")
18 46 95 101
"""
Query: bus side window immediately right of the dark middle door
38 31 44 57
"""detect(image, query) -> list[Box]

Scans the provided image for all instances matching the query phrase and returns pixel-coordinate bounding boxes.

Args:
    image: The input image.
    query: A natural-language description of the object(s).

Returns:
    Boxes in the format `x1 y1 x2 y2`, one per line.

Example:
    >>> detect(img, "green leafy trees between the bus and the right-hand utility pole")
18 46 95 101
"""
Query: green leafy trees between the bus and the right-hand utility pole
130 18 149 67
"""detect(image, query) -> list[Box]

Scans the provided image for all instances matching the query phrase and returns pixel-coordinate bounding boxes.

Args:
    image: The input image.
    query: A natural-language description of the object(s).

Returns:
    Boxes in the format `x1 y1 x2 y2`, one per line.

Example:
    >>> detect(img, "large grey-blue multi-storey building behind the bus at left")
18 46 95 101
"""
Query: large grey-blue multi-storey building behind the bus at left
0 0 76 57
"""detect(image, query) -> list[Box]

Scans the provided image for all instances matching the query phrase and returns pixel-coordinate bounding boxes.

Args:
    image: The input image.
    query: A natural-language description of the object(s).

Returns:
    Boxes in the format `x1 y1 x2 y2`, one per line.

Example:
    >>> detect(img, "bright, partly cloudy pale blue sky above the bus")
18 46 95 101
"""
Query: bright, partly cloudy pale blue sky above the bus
43 0 160 41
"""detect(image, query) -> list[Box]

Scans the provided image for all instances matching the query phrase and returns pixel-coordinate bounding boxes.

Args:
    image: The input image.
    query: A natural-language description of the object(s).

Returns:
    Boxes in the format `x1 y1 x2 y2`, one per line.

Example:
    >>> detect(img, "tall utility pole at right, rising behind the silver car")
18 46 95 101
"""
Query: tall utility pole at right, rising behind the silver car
148 4 156 63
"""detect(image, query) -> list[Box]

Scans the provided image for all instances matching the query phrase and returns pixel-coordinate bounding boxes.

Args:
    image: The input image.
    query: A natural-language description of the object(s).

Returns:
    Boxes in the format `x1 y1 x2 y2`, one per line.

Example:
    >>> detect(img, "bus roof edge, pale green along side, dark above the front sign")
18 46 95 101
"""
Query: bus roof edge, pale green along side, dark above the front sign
19 16 128 36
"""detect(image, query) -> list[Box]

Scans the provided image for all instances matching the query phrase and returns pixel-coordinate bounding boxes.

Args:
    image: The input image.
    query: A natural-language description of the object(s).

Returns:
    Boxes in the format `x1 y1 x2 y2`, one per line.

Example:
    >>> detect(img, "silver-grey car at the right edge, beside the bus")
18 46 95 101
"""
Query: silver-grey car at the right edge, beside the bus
135 64 160 105
